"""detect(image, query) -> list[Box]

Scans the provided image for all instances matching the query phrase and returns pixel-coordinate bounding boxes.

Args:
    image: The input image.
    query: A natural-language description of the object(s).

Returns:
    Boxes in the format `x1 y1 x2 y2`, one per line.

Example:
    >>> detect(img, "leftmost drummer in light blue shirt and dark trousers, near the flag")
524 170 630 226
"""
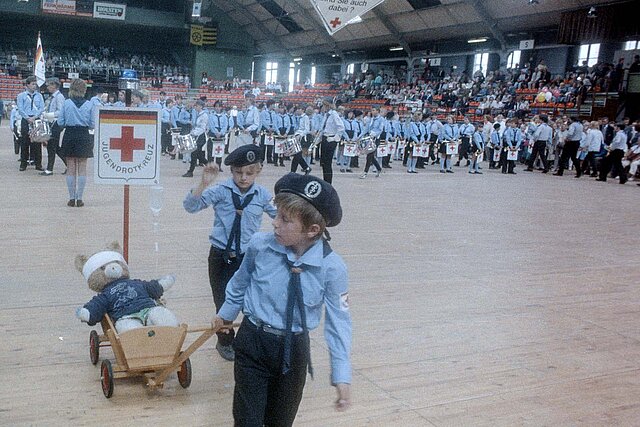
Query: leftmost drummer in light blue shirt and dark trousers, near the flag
17 76 44 172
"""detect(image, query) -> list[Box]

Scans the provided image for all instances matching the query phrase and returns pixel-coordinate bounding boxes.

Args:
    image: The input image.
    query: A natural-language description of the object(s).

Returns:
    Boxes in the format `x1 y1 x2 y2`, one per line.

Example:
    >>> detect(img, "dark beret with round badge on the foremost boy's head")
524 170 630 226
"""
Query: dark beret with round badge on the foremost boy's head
274 173 342 227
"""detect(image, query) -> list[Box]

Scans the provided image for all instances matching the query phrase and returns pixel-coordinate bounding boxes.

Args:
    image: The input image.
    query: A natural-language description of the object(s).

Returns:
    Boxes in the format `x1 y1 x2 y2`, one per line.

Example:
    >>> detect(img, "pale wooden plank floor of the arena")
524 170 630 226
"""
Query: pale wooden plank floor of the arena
0 122 640 426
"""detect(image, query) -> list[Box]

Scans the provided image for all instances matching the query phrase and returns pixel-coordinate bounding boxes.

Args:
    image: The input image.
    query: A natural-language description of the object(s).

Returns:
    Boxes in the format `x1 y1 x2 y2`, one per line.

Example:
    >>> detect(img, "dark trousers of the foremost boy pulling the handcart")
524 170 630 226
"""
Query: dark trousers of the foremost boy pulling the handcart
233 320 310 427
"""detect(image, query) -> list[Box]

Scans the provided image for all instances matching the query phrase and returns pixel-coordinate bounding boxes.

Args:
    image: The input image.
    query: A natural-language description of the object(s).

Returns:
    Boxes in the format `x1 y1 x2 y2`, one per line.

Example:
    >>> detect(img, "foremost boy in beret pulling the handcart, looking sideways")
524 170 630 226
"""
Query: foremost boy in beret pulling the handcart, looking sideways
214 174 351 426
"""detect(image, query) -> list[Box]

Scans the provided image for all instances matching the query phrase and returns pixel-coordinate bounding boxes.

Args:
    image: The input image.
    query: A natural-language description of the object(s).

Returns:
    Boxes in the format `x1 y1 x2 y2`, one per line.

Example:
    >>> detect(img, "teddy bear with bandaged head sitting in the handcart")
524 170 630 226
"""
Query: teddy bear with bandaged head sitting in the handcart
75 242 178 333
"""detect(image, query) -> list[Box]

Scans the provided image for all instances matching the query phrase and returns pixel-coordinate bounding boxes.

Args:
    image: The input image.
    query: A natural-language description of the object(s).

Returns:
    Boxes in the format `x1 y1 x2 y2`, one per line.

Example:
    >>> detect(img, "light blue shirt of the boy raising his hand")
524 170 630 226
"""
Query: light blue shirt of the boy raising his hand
182 178 276 253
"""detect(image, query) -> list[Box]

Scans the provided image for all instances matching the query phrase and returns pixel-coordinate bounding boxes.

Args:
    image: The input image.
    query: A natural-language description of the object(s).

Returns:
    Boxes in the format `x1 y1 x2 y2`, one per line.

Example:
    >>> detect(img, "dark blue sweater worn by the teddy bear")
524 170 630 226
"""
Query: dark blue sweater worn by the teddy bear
84 279 164 326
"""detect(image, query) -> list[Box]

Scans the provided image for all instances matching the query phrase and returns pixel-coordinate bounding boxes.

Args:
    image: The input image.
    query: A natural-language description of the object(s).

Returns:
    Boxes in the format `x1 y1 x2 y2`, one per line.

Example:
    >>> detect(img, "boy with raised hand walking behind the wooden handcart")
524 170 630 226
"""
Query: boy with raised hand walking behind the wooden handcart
183 144 276 360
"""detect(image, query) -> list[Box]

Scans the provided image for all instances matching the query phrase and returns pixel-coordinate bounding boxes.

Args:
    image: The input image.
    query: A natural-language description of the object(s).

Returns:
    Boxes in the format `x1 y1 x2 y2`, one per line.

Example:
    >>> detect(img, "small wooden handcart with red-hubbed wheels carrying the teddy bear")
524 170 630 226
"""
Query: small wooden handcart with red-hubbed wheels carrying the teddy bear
89 315 232 398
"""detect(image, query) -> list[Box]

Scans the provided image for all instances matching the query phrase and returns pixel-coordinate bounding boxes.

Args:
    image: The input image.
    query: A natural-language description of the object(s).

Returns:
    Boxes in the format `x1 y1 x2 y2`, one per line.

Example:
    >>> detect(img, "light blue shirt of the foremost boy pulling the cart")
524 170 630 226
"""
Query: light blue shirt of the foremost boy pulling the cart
218 233 351 384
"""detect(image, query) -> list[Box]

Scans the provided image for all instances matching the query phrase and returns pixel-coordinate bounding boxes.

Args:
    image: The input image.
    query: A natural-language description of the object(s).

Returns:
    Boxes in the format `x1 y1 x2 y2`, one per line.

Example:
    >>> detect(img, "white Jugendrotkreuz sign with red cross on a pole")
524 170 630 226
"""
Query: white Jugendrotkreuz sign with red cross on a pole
94 107 160 185
